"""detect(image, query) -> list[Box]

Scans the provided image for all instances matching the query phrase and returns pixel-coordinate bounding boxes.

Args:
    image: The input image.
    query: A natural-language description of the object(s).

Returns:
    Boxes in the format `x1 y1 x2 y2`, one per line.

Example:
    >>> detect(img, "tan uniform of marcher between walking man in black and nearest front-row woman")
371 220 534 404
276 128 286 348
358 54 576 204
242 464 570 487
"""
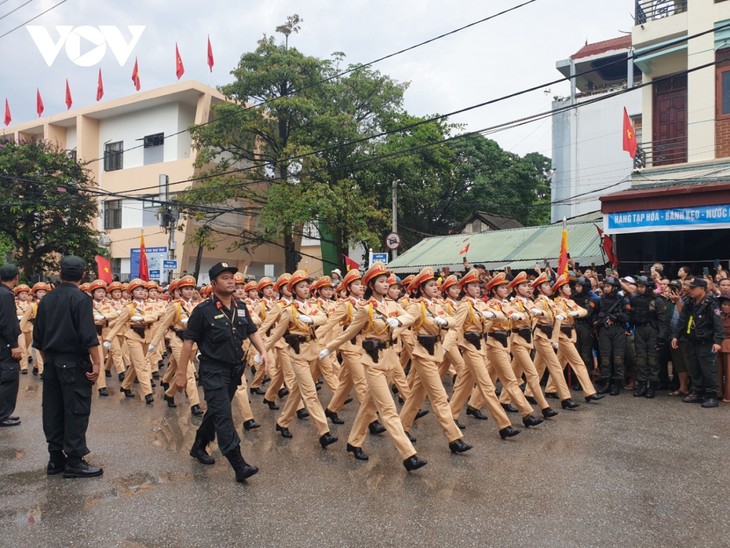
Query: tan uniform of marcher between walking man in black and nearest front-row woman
267 301 329 436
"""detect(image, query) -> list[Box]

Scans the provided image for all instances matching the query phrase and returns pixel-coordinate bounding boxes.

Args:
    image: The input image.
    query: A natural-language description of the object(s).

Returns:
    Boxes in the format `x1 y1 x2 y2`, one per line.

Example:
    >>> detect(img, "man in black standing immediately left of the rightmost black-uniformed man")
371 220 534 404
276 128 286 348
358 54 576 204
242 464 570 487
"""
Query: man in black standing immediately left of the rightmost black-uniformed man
629 276 669 398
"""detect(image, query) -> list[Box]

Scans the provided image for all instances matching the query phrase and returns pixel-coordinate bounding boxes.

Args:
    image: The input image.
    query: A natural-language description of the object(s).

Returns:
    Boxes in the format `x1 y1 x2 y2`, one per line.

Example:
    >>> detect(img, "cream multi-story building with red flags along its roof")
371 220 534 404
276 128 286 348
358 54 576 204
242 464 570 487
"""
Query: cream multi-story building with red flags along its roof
4 81 284 282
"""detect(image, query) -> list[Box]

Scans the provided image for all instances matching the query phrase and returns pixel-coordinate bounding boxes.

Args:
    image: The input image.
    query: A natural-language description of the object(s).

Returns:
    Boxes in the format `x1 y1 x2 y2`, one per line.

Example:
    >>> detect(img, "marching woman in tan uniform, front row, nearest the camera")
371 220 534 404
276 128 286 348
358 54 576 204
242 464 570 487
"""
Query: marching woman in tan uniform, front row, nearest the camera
319 262 427 472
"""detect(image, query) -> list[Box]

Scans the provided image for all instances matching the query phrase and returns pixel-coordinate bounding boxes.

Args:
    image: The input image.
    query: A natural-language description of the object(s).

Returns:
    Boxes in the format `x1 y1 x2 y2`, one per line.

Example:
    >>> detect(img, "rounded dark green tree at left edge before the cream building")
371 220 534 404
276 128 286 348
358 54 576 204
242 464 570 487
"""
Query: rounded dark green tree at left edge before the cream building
0 141 100 280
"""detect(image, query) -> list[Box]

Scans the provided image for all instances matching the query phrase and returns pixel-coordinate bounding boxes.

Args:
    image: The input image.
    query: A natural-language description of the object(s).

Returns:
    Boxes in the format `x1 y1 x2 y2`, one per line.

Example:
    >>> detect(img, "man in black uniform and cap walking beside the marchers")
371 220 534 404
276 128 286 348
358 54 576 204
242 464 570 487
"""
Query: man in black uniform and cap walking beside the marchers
175 263 268 481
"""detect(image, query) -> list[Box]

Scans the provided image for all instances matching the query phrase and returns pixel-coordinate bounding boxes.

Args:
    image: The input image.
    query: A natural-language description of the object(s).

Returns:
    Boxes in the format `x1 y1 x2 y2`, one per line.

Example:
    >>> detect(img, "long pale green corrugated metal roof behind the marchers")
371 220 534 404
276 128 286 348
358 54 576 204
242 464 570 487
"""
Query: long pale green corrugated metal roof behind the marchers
388 223 603 274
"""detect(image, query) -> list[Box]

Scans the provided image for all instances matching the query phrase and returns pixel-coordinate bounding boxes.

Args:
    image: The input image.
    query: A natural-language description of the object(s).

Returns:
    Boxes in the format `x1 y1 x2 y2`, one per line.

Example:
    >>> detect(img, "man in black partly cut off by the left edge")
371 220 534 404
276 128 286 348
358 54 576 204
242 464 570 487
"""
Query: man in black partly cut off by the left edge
0 264 20 426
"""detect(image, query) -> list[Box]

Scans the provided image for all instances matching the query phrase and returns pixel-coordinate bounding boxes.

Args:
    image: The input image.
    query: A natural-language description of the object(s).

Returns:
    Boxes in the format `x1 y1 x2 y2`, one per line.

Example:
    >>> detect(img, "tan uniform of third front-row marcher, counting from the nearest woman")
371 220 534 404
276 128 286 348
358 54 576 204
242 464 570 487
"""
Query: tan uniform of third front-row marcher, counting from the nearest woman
444 297 511 430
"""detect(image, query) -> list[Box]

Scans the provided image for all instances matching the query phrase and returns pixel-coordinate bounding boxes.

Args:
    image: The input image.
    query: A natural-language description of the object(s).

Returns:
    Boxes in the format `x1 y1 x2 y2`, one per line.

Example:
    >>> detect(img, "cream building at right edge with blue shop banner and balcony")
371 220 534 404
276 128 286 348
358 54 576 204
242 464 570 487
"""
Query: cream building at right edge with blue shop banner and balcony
601 0 730 274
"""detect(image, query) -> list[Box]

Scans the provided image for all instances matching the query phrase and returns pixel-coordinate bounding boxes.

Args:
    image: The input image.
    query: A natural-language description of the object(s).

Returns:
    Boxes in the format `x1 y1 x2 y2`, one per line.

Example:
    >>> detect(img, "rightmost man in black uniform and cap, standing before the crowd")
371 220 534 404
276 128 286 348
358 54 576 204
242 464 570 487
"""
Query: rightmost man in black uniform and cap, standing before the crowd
672 278 725 407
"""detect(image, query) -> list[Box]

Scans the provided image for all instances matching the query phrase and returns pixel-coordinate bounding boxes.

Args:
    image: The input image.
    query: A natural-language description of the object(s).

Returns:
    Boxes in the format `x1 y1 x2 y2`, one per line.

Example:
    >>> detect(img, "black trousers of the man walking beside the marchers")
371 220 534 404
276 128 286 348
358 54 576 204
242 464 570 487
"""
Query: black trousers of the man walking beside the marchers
196 363 244 455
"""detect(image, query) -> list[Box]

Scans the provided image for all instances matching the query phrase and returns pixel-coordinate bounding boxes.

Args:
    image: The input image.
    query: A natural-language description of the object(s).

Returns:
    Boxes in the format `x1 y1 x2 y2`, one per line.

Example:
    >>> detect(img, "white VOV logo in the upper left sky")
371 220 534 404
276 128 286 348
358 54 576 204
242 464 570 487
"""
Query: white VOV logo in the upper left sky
25 25 146 67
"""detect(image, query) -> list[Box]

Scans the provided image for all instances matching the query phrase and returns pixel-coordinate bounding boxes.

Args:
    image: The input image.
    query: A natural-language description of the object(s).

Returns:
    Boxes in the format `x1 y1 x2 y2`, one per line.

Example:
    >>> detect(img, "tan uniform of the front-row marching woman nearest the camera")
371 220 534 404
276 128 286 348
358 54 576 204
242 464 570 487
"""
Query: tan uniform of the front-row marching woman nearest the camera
326 299 416 459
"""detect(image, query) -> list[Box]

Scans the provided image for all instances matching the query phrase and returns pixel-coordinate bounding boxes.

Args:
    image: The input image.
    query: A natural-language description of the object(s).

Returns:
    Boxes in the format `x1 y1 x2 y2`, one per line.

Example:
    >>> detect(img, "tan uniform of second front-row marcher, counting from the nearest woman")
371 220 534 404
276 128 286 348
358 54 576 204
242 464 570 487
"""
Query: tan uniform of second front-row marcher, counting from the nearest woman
400 297 463 443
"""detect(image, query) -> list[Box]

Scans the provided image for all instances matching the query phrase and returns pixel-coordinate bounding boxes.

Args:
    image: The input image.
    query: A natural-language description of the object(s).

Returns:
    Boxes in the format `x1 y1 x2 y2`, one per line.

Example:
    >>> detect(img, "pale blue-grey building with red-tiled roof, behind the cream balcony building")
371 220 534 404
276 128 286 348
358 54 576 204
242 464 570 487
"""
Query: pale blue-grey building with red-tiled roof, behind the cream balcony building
550 35 641 222
